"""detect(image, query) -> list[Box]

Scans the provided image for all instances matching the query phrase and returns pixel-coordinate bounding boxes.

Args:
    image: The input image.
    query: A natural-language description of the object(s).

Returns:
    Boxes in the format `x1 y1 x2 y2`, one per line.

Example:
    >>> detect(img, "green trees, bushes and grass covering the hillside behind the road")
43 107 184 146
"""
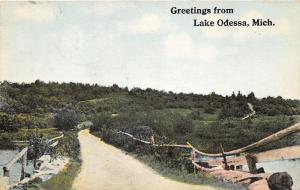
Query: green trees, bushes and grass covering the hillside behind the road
0 80 300 187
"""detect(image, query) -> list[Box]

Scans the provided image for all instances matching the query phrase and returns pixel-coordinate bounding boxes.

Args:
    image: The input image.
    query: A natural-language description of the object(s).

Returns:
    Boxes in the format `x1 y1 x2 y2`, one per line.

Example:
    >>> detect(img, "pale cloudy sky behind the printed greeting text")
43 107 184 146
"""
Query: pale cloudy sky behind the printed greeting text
0 1 300 99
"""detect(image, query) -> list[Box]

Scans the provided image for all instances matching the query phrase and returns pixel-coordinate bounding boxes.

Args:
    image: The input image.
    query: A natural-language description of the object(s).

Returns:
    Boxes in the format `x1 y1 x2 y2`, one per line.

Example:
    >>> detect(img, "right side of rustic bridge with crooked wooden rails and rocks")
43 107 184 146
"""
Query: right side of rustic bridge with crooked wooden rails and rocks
118 122 300 190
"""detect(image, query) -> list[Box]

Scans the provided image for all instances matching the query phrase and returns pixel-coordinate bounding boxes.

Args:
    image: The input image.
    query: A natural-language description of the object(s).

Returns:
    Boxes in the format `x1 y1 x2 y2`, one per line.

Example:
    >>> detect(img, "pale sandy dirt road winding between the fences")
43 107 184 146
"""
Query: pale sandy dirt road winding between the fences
73 130 215 190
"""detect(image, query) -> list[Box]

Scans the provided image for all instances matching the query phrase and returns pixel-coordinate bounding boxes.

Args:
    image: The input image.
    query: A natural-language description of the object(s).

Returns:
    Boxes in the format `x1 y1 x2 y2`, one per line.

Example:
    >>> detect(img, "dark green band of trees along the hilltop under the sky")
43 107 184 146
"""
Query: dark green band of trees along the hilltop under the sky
0 80 300 118
